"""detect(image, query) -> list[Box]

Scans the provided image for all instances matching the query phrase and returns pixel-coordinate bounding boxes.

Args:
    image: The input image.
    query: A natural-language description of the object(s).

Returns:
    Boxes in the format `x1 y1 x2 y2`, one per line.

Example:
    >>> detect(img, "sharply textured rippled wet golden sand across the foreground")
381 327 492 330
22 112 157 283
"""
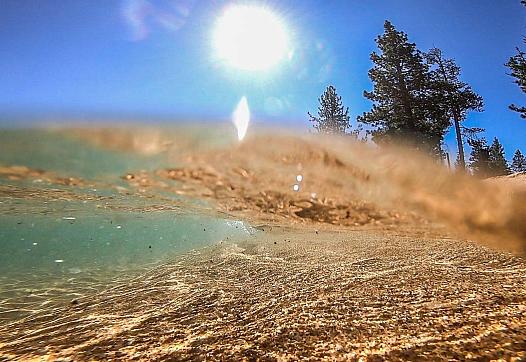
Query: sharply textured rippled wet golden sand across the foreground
0 226 526 361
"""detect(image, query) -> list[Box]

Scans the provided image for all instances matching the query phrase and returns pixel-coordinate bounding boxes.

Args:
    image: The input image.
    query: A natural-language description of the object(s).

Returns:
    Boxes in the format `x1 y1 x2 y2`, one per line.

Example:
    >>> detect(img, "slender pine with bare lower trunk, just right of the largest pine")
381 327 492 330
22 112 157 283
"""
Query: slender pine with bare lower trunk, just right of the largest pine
426 48 484 170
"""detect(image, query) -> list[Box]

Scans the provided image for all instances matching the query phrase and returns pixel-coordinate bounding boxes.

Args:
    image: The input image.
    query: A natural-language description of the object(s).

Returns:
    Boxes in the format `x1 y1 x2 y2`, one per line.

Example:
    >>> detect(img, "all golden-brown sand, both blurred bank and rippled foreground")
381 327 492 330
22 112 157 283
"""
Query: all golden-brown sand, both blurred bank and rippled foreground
0 130 526 360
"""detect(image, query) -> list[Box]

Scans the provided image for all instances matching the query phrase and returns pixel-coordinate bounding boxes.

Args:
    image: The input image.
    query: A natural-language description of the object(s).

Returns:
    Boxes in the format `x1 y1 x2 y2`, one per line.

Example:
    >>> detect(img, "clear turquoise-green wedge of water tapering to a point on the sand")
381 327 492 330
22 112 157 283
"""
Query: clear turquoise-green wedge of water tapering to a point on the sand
0 203 251 275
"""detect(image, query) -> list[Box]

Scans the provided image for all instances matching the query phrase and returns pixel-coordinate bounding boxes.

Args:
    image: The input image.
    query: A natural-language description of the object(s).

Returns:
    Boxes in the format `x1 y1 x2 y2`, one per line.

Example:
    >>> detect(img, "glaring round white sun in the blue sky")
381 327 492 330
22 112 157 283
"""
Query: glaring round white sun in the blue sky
213 5 289 71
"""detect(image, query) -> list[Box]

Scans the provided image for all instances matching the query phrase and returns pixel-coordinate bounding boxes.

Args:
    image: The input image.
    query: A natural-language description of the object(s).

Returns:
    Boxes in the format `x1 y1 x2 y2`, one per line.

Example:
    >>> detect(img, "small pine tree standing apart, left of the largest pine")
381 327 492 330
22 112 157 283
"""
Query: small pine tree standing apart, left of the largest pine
308 85 350 135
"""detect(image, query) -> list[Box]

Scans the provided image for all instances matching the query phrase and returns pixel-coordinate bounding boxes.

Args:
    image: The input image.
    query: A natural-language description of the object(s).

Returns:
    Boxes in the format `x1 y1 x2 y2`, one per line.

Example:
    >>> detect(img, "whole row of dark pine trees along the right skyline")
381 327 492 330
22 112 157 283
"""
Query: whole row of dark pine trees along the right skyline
308 12 526 178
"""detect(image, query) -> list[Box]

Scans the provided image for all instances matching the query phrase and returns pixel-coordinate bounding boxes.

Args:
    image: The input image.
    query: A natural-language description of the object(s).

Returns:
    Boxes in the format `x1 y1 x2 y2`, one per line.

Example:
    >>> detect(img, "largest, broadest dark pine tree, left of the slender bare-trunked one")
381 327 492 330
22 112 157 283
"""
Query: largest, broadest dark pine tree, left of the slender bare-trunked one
358 21 449 155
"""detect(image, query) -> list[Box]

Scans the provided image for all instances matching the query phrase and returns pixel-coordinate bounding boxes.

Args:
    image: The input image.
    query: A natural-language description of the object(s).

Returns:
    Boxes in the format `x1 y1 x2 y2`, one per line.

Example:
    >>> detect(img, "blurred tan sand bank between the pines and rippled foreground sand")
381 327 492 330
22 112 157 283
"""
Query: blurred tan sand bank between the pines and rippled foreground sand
90 126 526 253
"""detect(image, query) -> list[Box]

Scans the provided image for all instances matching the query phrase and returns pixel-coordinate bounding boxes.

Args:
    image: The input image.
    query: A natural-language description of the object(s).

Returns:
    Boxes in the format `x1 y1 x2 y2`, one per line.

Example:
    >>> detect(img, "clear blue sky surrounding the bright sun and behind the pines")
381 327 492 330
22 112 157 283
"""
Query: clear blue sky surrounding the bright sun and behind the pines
0 0 526 158
